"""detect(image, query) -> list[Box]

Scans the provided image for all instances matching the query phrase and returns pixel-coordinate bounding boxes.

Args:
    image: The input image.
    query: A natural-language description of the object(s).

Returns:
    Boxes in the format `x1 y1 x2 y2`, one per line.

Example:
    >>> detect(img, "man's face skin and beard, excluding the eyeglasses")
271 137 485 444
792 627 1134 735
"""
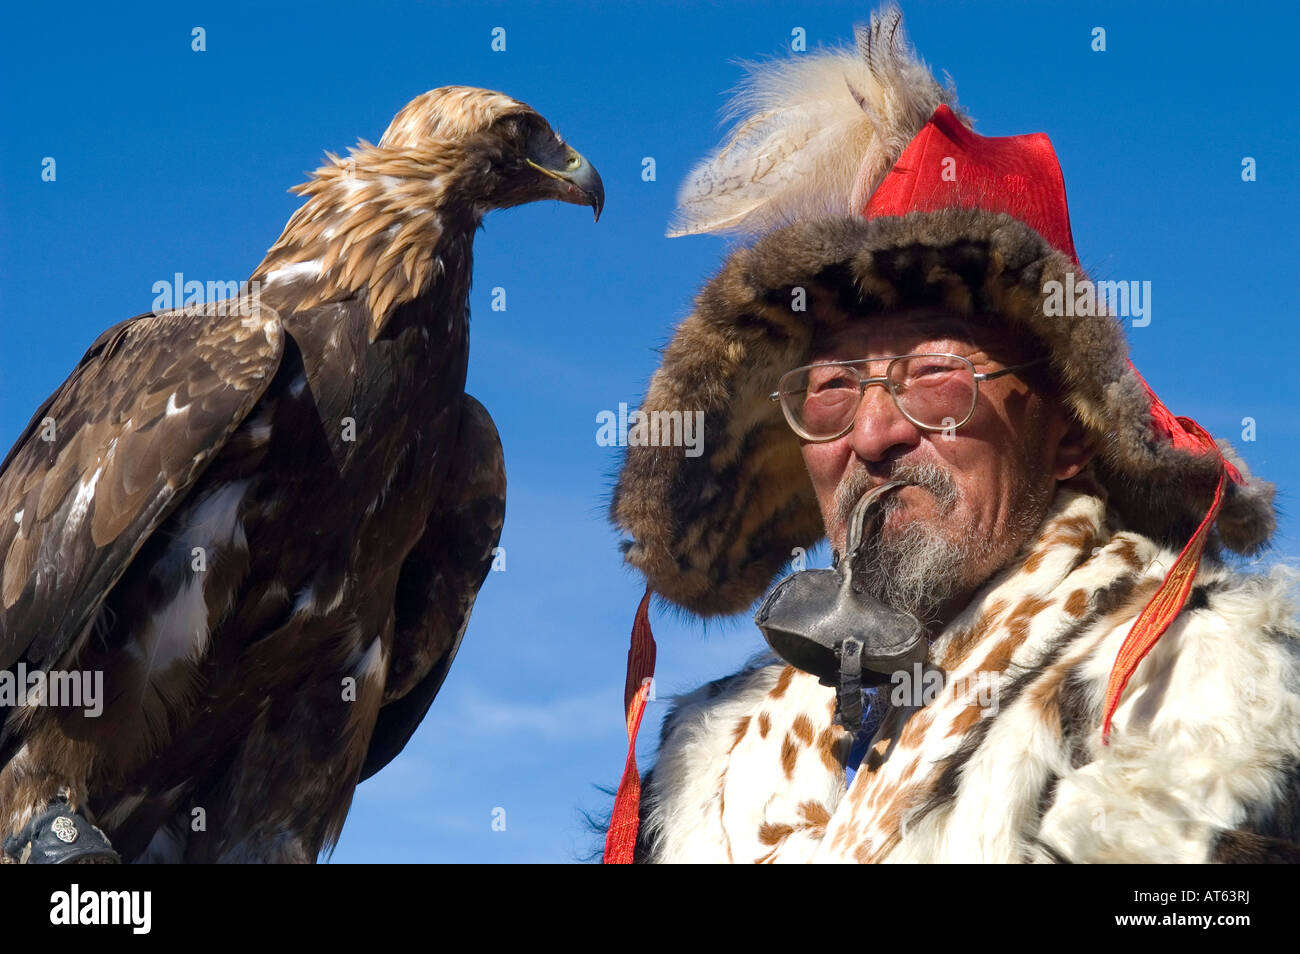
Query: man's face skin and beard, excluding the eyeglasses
803 311 1088 626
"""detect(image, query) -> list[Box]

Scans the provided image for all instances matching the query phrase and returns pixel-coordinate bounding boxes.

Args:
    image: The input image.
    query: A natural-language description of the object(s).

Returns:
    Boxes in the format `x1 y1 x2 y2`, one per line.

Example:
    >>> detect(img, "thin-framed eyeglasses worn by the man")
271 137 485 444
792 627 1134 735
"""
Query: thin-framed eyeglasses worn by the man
771 355 1047 441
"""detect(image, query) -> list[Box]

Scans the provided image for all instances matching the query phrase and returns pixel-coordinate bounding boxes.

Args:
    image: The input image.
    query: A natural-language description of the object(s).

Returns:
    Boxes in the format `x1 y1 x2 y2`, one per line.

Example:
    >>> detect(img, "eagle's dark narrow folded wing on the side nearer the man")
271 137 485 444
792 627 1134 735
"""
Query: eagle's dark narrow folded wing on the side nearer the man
361 394 506 781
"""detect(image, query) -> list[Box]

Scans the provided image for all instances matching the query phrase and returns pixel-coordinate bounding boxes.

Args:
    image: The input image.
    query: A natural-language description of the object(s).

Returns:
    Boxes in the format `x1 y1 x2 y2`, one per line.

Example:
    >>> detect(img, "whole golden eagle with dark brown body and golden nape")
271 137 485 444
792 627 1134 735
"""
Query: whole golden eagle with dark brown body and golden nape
0 87 605 862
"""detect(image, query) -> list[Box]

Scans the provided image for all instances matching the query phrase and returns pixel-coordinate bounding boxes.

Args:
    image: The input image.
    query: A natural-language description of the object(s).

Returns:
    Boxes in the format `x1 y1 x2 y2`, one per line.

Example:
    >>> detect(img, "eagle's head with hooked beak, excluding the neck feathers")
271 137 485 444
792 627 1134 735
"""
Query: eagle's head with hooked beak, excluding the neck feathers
380 86 605 218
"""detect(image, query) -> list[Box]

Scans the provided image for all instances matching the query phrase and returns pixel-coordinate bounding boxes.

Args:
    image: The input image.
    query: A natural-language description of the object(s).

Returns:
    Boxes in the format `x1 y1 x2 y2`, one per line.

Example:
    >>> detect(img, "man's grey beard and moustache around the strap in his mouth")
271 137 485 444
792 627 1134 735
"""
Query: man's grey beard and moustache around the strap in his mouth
835 464 1047 626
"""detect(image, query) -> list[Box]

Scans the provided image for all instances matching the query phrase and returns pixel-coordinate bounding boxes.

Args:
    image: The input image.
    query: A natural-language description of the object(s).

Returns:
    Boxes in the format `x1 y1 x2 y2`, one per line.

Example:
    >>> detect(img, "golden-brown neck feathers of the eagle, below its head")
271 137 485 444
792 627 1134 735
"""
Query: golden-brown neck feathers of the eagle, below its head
252 142 482 341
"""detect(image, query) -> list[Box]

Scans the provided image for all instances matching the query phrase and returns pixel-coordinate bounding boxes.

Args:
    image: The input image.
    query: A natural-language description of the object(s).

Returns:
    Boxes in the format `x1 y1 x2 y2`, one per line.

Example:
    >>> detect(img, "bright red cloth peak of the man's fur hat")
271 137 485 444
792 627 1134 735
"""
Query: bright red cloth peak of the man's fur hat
862 105 1079 261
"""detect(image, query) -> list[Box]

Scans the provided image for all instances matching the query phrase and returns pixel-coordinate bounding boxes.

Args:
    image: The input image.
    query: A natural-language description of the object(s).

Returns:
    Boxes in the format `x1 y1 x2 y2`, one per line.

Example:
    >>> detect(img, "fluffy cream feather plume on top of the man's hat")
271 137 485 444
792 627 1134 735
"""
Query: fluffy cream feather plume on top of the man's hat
668 5 970 237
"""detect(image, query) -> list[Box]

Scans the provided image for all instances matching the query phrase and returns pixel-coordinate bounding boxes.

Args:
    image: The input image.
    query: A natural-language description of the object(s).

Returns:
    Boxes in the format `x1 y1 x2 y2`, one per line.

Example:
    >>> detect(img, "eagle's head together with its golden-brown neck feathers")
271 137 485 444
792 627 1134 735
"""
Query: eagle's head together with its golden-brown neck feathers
252 86 605 341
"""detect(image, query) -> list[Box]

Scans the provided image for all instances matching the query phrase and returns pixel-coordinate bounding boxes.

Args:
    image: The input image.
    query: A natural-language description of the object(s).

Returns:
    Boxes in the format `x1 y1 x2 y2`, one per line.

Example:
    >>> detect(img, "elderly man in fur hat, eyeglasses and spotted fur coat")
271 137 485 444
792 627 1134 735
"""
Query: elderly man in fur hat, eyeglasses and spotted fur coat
607 10 1300 862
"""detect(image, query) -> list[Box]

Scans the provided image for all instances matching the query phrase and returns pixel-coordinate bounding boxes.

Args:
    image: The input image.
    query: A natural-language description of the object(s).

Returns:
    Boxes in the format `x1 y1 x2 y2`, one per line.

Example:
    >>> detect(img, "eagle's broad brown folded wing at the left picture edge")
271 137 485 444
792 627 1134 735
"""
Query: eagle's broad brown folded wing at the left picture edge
0 299 283 669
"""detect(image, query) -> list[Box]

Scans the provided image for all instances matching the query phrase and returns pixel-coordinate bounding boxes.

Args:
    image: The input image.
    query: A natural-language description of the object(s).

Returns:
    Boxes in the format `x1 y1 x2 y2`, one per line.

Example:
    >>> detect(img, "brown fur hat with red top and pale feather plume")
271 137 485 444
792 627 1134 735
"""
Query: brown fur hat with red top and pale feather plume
611 8 1274 621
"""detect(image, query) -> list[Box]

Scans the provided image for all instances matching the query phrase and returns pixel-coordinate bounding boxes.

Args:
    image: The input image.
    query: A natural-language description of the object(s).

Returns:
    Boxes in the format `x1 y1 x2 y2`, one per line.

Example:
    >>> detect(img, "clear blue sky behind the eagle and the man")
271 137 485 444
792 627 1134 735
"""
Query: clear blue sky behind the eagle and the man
0 3 1300 863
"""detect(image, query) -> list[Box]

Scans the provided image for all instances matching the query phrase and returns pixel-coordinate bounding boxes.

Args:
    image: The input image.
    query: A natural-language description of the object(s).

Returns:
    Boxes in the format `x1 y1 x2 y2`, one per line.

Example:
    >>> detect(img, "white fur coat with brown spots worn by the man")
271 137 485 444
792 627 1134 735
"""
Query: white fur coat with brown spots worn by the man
637 480 1300 862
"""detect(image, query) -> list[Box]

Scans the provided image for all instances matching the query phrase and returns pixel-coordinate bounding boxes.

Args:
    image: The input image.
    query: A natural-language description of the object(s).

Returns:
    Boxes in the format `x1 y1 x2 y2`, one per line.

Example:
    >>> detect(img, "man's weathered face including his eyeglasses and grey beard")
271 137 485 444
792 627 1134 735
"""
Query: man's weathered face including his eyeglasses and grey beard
780 309 1091 633
